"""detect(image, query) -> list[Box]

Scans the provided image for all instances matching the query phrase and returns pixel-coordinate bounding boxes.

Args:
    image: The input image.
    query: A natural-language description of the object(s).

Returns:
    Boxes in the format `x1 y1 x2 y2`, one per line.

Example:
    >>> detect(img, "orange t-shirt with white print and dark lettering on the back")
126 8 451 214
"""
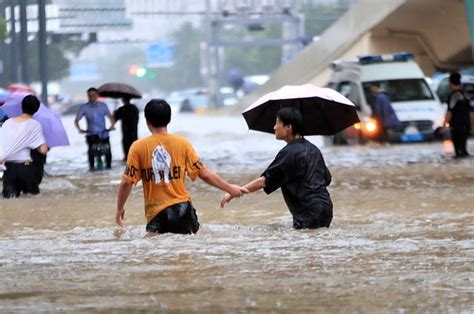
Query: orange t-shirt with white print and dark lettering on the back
123 134 205 223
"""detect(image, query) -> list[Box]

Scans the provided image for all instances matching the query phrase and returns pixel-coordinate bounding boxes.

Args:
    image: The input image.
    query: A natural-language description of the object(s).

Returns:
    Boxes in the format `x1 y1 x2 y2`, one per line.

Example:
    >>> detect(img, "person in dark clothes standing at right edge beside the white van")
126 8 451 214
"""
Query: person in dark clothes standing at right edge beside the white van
445 72 471 158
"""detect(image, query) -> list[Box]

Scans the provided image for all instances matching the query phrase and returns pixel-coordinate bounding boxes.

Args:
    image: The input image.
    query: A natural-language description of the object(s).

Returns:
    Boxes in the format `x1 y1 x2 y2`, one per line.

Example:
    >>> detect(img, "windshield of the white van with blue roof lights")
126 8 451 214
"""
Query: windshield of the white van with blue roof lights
362 79 434 103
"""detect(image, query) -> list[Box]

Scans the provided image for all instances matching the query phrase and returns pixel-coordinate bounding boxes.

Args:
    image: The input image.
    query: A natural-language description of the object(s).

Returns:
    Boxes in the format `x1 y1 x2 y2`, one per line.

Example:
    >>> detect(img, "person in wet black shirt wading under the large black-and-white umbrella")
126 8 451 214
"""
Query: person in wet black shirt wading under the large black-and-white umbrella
221 107 333 229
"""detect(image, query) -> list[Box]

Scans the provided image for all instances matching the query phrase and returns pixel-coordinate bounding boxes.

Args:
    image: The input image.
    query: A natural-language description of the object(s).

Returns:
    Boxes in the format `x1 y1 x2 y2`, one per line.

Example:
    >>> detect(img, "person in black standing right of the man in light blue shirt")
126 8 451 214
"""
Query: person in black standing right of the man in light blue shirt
113 98 138 161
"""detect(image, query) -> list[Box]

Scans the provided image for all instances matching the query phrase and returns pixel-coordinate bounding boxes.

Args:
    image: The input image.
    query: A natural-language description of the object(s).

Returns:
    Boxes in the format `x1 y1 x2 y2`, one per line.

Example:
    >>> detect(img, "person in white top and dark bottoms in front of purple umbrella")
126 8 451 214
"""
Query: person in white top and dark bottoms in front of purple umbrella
0 95 48 198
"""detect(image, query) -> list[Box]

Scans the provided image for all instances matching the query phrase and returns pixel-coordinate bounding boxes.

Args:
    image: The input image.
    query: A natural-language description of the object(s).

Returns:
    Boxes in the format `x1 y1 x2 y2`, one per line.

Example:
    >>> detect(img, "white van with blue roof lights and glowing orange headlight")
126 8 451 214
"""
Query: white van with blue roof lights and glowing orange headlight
327 53 446 142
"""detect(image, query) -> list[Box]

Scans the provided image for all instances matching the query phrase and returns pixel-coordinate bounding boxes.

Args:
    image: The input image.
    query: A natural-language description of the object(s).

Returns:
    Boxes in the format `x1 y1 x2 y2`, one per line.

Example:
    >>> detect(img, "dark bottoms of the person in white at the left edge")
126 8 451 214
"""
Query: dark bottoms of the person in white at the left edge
2 162 40 198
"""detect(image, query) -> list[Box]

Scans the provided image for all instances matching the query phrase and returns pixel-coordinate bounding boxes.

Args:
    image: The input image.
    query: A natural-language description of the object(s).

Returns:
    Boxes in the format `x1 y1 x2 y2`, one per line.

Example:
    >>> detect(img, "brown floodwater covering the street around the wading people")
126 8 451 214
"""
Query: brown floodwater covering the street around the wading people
0 113 474 313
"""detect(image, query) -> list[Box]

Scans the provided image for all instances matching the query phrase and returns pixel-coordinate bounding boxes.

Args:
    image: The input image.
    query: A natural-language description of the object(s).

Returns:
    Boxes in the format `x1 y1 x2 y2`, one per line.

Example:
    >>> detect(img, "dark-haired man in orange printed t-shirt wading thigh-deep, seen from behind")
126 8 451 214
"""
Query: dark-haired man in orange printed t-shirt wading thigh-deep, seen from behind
115 99 248 234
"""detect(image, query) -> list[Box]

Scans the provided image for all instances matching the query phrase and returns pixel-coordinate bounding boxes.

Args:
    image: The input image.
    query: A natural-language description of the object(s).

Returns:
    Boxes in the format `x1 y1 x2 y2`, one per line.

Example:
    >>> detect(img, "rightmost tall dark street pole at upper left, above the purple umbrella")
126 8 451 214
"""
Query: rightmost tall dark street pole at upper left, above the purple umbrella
38 0 48 106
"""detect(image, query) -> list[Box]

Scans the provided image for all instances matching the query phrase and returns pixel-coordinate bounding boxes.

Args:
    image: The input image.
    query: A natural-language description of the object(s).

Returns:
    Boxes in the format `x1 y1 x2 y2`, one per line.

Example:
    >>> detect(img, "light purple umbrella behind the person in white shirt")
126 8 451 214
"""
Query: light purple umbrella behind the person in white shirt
0 93 69 148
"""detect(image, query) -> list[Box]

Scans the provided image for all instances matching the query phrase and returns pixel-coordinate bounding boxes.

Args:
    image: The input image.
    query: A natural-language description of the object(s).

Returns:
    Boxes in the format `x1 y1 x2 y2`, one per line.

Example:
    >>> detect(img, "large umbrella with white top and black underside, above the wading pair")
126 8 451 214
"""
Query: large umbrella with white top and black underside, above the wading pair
242 84 359 135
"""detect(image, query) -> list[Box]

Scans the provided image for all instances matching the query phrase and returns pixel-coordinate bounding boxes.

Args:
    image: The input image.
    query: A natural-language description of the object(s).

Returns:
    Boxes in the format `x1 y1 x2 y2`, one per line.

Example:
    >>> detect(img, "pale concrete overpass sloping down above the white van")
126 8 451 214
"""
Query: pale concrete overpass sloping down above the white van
241 0 474 106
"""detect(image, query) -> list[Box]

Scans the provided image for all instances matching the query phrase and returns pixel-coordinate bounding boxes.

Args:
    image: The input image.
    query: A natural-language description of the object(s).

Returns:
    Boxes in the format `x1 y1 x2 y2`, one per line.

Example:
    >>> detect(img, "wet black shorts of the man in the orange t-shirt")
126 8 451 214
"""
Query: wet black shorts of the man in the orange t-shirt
146 202 199 234
